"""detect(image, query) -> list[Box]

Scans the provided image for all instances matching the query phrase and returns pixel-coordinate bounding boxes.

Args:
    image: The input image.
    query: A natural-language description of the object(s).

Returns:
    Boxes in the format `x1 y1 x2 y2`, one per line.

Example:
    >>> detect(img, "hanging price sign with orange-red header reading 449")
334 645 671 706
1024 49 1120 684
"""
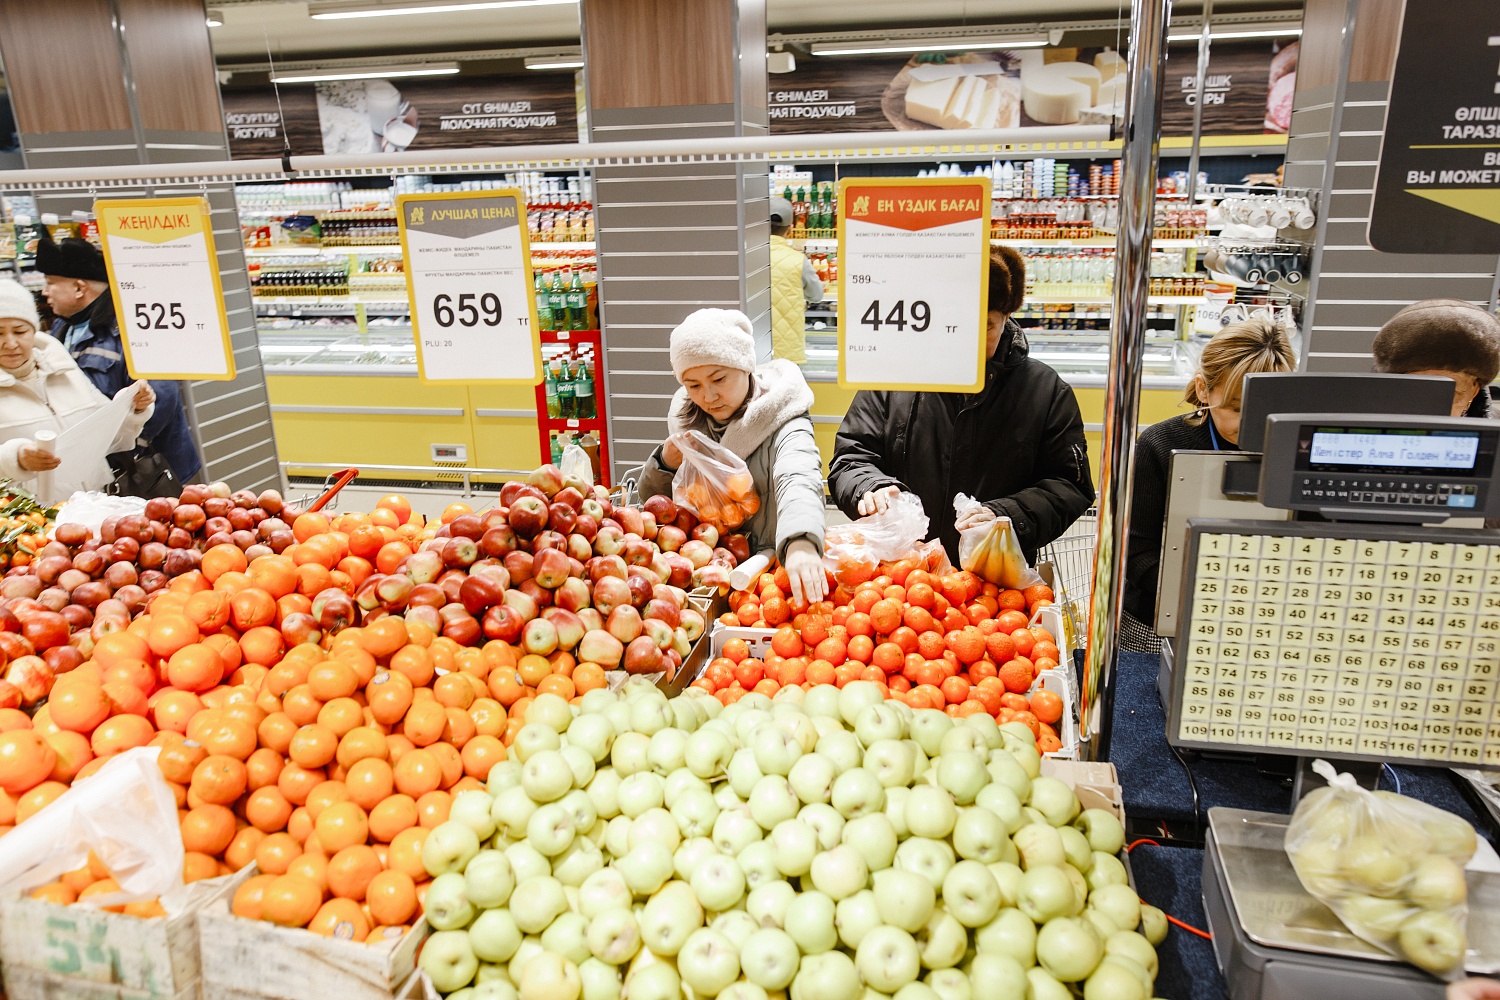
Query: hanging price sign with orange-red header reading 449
839 177 990 393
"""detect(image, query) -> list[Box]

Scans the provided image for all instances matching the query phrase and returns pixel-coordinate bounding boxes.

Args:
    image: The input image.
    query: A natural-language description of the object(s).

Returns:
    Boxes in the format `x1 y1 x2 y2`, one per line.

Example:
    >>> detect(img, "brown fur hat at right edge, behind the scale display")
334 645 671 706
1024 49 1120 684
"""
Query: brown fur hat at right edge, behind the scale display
1371 298 1500 385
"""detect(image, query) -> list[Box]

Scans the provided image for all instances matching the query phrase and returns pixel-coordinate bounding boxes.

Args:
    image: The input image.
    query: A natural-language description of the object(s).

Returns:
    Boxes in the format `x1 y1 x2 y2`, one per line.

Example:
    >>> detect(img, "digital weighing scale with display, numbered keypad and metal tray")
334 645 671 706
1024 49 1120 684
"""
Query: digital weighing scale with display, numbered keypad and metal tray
1167 414 1500 1000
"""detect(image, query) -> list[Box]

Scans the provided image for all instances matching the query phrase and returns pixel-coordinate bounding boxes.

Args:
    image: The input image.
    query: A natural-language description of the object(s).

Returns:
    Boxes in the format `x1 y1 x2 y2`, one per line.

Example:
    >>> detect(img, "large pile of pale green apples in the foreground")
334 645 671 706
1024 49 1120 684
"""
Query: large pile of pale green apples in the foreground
419 678 1167 1000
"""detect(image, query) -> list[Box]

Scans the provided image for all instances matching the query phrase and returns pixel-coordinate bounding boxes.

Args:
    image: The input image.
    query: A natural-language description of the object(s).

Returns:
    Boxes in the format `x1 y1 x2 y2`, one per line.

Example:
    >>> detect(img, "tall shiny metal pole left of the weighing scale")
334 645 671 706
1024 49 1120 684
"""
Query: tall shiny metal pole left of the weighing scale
1080 0 1172 760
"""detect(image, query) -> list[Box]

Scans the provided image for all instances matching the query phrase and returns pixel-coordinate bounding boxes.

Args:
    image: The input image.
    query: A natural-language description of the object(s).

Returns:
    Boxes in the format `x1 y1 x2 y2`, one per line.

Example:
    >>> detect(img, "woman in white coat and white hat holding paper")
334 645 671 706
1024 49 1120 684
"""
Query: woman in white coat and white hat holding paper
0 280 156 499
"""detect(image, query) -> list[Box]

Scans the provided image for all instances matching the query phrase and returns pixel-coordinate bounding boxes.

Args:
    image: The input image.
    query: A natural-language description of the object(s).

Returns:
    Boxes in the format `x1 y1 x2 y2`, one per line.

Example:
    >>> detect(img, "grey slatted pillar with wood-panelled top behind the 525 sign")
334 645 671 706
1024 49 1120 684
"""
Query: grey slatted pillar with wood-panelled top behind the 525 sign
0 0 282 490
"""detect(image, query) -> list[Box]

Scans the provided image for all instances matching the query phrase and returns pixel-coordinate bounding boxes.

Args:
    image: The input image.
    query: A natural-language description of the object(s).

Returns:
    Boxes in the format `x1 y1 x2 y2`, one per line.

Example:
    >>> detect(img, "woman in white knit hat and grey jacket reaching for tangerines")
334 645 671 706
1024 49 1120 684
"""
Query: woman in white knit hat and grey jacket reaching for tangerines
641 309 828 604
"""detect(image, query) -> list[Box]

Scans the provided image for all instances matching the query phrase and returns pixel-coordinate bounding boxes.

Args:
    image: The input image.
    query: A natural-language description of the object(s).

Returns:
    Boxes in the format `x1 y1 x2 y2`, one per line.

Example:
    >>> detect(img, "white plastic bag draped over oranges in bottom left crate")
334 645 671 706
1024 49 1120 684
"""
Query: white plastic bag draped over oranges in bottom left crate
0 747 185 913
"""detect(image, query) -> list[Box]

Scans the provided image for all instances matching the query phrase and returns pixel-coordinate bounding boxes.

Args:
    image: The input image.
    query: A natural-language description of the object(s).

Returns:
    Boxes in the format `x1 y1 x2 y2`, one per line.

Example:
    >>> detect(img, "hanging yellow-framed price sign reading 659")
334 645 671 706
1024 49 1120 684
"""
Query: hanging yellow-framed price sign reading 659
396 187 542 385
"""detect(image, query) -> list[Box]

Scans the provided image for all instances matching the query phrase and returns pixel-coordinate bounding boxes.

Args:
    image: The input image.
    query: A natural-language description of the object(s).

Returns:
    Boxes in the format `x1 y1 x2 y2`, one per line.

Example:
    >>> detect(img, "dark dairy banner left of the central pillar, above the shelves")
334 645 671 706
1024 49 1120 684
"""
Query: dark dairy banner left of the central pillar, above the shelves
224 73 579 159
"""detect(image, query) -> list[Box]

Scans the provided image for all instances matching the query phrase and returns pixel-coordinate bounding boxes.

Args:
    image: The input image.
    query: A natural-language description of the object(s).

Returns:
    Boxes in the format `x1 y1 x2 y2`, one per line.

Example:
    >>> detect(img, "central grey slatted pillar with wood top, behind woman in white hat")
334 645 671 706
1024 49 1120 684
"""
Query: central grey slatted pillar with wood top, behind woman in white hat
582 0 771 481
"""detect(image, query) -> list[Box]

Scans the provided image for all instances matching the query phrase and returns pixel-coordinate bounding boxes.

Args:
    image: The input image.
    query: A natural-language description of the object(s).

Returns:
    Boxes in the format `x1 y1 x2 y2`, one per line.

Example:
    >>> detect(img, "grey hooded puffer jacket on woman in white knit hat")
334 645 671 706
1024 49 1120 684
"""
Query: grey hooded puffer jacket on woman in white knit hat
641 360 824 559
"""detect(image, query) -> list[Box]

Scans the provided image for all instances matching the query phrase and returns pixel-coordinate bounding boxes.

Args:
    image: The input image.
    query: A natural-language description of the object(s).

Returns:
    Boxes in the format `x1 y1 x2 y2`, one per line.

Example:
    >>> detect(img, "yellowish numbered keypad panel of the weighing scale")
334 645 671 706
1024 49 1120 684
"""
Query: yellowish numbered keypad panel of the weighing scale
1178 532 1500 766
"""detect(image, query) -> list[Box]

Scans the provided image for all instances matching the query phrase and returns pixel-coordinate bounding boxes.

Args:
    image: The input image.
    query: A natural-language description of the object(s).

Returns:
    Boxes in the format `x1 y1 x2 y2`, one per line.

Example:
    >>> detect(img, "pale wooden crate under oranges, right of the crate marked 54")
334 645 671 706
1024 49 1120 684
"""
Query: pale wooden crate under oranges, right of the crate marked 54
198 900 431 1000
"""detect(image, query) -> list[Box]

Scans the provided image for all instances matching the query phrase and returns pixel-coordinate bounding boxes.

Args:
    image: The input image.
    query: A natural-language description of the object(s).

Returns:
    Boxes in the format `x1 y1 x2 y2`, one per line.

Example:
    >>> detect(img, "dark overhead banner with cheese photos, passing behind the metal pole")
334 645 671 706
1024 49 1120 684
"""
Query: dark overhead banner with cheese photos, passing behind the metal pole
768 40 1298 136
